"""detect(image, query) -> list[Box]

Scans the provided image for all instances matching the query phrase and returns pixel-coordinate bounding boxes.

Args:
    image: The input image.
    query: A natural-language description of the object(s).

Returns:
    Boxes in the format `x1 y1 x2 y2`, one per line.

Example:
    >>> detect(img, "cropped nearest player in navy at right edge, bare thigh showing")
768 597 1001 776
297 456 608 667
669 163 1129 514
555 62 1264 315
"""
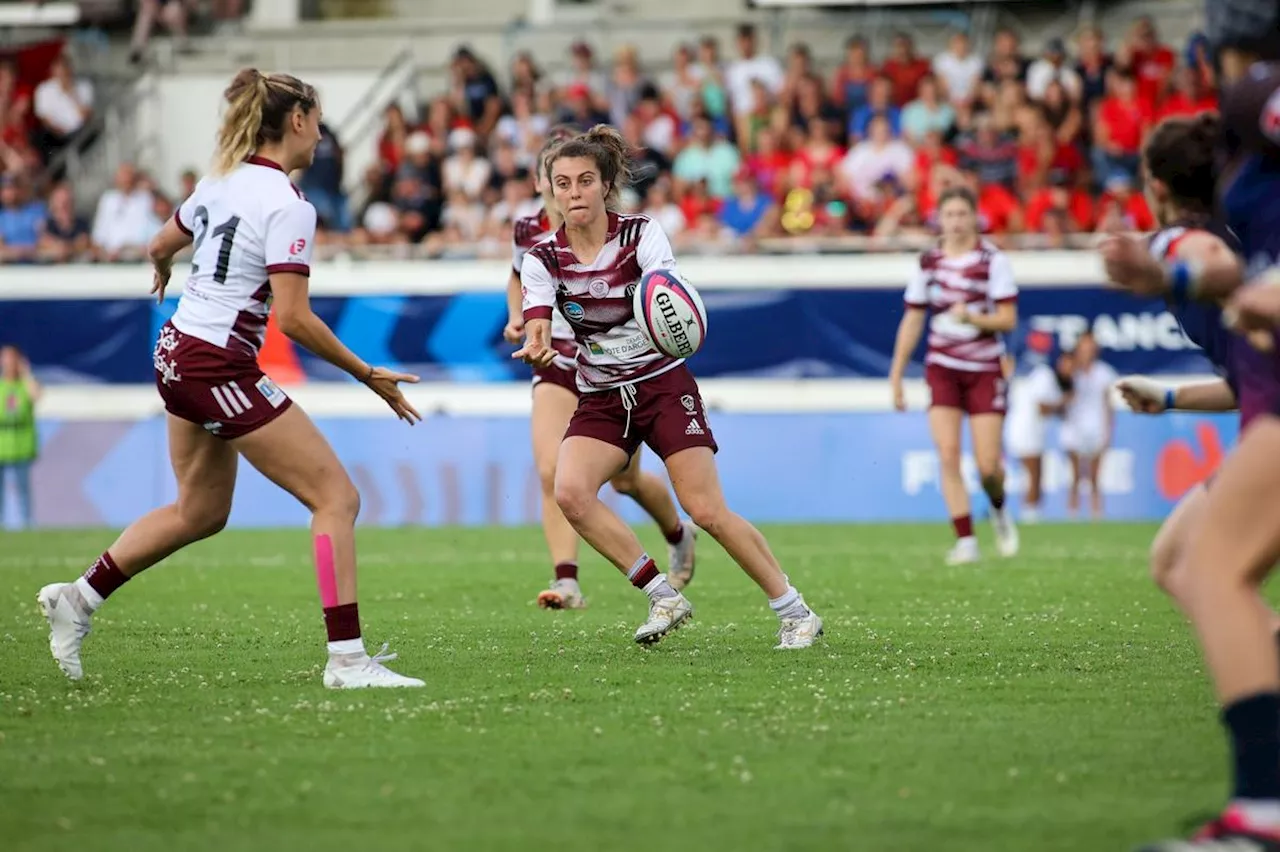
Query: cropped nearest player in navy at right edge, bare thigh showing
1100 13 1280 852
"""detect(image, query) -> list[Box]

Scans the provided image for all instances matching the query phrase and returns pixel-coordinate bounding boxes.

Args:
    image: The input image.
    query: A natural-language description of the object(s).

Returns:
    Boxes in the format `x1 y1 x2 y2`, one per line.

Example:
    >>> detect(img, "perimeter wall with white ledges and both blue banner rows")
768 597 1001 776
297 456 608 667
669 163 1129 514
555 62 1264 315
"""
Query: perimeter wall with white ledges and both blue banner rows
0 252 1235 527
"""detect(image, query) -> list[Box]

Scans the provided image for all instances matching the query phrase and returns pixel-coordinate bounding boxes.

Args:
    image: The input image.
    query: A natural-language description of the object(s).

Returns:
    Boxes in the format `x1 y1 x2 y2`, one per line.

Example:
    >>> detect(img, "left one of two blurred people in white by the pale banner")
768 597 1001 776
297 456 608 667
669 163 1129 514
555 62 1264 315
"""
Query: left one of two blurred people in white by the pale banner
1005 331 1070 523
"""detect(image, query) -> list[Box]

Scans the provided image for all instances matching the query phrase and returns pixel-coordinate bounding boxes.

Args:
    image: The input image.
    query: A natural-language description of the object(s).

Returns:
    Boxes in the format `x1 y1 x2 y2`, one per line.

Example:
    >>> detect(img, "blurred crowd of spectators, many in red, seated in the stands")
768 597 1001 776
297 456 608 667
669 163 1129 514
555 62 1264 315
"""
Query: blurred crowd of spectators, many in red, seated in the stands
0 18 1216 262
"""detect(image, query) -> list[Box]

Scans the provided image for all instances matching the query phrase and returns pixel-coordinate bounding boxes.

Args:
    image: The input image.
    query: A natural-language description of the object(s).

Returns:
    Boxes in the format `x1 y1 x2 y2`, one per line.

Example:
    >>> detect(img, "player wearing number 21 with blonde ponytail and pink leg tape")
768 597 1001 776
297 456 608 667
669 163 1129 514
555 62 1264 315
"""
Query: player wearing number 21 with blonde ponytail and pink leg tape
38 69 422 688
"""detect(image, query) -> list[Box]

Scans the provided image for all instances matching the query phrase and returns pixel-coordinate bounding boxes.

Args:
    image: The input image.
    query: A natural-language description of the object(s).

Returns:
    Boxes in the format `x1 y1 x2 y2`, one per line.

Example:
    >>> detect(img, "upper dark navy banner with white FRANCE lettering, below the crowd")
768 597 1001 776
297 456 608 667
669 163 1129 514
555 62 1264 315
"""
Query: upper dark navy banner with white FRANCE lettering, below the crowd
0 285 1210 384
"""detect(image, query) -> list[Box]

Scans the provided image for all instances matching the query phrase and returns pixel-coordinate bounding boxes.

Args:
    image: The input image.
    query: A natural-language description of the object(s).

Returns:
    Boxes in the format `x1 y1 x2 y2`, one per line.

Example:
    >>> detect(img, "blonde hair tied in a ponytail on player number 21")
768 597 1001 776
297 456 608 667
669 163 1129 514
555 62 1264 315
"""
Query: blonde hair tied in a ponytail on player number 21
212 68 319 174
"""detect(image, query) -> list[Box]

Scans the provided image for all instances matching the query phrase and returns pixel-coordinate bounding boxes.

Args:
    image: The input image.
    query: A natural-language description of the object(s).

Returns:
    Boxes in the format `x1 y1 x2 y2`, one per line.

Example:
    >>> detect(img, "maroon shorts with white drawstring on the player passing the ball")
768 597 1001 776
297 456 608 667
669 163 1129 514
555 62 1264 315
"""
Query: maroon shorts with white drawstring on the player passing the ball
564 365 719 459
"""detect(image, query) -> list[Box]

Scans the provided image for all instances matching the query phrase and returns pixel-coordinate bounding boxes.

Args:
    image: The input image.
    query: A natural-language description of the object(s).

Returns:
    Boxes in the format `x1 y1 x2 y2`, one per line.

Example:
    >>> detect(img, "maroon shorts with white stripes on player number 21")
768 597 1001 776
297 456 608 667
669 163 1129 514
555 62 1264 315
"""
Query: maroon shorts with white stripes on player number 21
152 322 293 440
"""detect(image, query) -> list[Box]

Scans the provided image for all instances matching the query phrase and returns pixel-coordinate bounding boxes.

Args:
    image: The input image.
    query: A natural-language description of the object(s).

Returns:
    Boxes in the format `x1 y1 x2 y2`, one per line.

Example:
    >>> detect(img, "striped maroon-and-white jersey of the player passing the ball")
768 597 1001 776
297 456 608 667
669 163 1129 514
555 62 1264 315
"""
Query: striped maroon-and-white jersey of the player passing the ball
520 212 684 393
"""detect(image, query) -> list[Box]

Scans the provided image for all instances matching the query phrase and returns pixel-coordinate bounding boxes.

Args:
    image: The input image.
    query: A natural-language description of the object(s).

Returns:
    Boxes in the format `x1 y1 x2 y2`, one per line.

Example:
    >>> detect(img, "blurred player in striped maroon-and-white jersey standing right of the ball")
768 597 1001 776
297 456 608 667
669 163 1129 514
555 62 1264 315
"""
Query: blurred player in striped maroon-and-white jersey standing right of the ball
888 187 1018 565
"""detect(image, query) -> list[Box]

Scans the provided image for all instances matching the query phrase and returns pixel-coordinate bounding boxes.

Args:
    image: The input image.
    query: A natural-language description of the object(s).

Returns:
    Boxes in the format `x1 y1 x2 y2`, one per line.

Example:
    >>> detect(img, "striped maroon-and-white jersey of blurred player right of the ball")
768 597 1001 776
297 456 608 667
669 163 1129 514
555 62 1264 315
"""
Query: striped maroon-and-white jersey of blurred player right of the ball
906 241 1018 372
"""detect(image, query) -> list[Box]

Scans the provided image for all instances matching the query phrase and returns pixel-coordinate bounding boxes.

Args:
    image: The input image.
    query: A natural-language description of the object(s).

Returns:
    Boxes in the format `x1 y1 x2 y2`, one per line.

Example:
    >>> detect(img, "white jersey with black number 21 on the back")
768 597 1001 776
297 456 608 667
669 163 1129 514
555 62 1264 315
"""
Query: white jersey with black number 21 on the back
173 157 316 356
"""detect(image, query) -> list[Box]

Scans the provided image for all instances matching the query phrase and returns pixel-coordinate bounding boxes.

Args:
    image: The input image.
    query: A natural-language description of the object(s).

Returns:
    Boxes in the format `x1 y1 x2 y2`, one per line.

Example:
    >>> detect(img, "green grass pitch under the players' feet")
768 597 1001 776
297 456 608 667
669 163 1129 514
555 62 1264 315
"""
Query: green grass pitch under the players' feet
0 525 1226 852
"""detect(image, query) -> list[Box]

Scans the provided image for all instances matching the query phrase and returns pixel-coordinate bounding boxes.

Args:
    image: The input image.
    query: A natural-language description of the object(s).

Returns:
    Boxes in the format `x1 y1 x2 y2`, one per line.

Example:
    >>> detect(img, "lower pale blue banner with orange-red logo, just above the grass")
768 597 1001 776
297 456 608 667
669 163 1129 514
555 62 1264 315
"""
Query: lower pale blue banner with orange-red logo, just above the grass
10 412 1236 527
